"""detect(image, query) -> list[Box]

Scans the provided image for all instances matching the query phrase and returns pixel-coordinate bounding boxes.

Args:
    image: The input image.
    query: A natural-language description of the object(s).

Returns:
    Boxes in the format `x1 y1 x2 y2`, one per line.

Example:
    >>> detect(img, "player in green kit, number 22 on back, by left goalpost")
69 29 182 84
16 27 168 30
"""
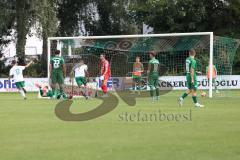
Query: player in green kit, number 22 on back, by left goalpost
49 50 67 99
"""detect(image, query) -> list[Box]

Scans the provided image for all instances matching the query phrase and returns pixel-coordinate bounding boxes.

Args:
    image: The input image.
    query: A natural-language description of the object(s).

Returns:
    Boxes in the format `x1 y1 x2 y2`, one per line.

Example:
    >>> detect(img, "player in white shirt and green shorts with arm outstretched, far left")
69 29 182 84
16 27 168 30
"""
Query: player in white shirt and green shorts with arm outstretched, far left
9 60 33 100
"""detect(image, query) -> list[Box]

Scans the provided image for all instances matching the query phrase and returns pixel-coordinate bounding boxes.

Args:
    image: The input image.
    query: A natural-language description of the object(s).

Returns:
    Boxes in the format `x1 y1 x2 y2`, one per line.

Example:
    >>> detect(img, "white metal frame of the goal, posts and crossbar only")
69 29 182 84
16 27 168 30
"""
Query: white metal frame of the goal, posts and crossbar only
47 32 214 98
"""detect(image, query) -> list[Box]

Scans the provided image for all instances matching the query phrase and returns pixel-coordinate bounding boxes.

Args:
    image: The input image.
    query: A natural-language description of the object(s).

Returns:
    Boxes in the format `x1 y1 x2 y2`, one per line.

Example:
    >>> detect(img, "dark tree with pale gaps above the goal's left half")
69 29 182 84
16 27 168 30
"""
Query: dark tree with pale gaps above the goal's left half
58 0 137 36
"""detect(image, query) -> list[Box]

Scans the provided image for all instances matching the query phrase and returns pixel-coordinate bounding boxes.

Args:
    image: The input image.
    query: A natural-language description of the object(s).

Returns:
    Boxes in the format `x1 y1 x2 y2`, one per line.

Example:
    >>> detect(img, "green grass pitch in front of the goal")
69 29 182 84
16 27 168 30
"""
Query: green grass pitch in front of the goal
0 91 240 160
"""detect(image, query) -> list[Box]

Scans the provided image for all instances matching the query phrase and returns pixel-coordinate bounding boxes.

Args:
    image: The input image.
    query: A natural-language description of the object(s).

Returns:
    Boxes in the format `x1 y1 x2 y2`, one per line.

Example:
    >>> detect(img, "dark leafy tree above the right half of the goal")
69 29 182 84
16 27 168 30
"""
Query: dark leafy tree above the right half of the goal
130 0 240 37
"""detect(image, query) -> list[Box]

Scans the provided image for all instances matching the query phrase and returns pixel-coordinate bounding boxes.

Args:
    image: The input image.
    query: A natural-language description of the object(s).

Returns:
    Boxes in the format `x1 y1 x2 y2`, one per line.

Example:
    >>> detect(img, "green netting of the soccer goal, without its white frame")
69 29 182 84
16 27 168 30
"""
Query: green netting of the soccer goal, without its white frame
48 35 240 95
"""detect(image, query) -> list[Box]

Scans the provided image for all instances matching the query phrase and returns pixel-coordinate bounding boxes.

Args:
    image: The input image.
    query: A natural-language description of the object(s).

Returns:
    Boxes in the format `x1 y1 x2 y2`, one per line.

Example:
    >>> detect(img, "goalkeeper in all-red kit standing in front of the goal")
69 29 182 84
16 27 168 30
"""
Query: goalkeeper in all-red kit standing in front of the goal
100 54 111 97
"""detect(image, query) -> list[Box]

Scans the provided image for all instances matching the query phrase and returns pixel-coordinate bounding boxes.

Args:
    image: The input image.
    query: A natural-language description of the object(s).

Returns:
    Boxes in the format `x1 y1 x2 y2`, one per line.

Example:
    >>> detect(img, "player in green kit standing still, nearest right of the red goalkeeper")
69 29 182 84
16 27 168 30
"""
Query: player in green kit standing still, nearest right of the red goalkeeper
147 51 160 100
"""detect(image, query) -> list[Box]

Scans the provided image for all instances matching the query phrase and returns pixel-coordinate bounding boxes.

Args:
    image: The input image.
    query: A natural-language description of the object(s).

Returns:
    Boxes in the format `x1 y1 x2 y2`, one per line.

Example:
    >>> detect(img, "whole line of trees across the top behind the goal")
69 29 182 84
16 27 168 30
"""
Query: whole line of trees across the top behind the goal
0 0 240 74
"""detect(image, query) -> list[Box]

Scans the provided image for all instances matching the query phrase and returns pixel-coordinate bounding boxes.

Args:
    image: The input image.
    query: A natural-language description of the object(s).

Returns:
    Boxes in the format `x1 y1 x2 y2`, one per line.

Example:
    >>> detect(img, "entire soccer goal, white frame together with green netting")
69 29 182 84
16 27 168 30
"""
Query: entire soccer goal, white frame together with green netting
48 32 239 97
